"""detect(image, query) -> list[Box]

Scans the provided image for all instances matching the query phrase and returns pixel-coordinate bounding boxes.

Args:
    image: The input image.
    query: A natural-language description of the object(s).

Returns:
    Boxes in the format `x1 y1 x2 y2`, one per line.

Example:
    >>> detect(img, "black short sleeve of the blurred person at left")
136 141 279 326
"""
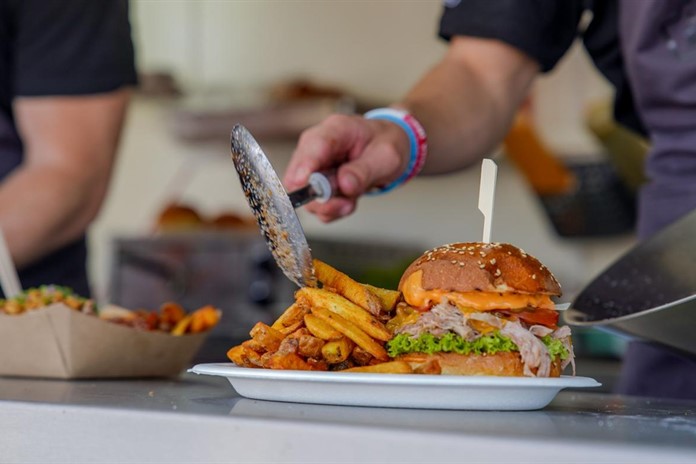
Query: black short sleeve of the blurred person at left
11 0 137 96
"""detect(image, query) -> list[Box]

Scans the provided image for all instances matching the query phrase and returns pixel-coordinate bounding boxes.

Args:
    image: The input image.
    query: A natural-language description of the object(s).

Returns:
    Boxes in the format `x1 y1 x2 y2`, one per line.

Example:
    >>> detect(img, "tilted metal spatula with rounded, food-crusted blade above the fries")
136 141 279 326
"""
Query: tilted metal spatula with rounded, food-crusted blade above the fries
230 124 332 287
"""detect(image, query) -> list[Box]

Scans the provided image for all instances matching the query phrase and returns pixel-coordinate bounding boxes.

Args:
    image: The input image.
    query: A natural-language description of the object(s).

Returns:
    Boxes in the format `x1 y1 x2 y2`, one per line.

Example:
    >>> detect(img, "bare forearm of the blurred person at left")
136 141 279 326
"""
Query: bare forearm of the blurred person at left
0 89 130 268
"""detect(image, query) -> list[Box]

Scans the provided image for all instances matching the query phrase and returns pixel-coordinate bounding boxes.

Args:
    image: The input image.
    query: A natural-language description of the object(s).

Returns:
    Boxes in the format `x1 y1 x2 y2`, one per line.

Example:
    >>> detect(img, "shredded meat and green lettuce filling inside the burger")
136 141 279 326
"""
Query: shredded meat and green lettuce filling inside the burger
388 301 575 377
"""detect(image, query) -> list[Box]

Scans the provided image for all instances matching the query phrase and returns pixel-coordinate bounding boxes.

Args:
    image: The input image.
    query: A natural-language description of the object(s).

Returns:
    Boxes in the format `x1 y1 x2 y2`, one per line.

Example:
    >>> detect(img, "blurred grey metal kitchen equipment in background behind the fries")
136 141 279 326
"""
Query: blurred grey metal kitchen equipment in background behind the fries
110 230 295 362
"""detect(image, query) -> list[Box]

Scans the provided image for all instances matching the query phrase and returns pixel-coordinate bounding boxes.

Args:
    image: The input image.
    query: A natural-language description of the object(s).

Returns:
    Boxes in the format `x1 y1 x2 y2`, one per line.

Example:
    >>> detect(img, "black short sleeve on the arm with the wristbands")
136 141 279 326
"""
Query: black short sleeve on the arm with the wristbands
440 0 583 72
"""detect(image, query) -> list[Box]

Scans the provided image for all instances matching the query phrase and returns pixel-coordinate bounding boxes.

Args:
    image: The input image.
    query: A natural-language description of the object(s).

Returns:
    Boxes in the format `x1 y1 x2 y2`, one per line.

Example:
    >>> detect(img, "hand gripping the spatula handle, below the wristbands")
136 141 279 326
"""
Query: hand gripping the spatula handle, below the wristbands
283 114 409 222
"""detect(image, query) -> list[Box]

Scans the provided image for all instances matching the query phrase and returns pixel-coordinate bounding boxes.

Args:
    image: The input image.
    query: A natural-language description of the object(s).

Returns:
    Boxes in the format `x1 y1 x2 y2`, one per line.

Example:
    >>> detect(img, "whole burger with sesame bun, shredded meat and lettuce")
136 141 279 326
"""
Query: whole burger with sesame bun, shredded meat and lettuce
387 242 575 377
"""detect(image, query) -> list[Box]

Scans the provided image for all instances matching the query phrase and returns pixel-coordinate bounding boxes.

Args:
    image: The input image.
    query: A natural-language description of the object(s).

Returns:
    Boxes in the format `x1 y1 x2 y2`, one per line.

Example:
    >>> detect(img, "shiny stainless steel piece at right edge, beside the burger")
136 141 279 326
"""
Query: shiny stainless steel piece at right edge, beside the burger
564 210 696 354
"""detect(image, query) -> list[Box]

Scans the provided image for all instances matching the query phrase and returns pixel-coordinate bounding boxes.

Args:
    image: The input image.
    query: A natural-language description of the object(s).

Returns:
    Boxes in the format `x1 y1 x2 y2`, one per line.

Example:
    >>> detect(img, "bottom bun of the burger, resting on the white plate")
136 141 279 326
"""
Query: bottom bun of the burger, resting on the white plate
397 352 561 377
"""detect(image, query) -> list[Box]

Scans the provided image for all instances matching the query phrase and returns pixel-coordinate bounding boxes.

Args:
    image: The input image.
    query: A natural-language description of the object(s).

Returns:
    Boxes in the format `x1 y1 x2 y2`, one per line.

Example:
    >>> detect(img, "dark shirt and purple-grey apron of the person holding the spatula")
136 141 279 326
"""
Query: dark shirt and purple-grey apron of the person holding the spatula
440 0 696 238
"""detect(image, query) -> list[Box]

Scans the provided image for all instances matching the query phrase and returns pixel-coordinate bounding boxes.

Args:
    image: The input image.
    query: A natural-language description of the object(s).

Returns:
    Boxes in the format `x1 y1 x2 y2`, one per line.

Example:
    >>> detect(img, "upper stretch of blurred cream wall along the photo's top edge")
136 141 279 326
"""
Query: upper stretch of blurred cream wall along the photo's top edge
132 0 445 99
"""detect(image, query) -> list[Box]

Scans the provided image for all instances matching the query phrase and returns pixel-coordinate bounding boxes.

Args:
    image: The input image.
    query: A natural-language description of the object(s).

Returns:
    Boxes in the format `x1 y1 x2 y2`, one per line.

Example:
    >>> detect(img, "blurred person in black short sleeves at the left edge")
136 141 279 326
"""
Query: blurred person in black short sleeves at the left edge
0 0 136 296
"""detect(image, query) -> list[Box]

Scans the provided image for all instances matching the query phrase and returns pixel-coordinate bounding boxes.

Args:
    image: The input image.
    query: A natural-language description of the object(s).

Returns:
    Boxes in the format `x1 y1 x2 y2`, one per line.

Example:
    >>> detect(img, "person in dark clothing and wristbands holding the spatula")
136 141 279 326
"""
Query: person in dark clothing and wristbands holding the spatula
284 0 696 398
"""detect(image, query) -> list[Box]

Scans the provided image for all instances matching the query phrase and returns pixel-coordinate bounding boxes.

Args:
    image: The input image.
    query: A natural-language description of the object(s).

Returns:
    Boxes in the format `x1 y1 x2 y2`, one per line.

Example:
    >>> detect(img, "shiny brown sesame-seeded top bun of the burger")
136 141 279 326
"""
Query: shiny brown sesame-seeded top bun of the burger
399 242 561 296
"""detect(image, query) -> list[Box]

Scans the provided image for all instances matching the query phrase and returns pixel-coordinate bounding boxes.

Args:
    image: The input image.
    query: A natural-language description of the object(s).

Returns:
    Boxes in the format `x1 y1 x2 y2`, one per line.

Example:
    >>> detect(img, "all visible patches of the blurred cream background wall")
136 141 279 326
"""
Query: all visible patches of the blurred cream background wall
85 0 632 295
